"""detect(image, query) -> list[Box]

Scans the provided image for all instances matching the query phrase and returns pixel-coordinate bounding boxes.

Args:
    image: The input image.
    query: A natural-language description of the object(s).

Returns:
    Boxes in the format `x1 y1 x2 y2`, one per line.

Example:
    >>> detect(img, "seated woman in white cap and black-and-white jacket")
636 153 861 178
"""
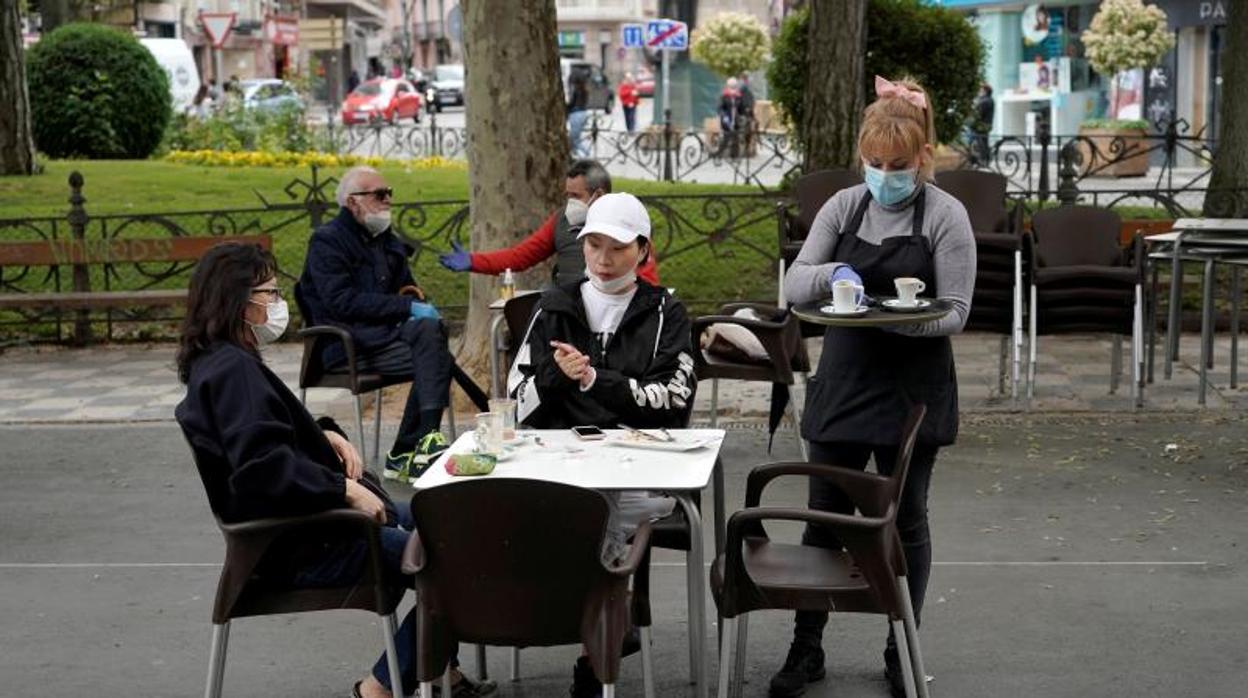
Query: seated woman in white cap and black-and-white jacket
508 194 696 697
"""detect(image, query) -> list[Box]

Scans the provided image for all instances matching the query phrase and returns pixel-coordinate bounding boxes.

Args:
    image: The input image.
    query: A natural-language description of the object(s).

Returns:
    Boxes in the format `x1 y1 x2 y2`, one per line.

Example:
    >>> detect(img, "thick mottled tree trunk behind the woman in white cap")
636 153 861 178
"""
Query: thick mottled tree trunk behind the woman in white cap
458 0 568 402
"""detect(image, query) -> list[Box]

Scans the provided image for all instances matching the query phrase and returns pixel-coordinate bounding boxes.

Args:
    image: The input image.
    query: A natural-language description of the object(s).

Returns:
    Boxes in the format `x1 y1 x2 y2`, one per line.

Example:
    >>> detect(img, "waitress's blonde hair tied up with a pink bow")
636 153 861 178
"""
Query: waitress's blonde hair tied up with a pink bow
859 77 936 181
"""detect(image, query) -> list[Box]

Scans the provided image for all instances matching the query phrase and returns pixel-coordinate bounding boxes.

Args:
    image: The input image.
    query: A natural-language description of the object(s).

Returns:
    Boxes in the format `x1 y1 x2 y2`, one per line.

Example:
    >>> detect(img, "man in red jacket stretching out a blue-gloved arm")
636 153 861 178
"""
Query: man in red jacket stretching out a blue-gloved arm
438 160 659 286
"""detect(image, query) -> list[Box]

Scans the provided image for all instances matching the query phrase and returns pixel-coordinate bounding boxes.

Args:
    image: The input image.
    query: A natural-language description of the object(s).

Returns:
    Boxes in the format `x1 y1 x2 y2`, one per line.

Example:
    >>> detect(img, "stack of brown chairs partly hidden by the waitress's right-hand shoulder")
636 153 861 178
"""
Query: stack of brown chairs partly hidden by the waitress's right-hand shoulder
936 170 1026 397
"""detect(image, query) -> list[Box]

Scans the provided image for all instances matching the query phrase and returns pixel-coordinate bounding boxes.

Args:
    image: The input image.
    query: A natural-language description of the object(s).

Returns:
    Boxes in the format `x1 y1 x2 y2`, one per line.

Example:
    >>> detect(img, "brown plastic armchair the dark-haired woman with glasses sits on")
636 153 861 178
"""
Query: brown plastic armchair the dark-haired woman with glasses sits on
183 431 403 698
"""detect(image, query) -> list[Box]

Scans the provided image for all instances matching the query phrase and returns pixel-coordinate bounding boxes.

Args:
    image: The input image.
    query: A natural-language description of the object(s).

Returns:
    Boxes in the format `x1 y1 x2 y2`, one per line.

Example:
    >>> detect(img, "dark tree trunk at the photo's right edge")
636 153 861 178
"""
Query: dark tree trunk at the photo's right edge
1204 2 1248 217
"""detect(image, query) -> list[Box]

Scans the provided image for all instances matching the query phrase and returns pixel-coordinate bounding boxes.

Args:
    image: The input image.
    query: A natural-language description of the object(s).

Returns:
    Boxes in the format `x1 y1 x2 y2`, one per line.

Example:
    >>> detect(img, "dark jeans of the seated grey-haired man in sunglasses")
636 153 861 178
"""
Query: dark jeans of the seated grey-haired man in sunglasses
346 320 453 447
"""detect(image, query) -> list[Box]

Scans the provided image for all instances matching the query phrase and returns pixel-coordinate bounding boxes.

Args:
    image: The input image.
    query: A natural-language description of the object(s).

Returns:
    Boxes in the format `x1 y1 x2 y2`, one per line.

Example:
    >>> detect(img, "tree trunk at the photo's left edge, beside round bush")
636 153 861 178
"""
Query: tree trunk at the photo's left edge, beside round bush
0 2 35 175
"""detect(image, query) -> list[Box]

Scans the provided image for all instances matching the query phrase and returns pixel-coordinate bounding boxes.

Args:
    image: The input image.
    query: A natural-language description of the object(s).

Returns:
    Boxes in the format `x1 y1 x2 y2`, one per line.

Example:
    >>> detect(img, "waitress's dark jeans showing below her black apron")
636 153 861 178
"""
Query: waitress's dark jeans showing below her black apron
792 441 940 647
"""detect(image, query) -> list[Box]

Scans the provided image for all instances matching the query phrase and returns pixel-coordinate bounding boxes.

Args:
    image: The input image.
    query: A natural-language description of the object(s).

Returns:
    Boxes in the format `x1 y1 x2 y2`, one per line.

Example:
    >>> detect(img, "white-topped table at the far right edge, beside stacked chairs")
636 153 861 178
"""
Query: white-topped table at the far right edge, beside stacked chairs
1144 219 1248 405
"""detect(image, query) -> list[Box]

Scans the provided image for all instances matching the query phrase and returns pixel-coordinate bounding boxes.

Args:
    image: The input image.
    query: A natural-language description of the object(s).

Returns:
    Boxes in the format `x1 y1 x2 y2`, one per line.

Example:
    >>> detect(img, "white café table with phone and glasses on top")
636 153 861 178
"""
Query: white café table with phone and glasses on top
414 430 724 696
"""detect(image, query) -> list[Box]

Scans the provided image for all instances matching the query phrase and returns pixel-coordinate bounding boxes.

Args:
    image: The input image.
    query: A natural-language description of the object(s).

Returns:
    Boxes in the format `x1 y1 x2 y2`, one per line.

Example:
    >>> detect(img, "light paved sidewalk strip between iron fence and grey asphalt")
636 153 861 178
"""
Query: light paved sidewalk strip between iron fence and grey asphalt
0 333 1248 423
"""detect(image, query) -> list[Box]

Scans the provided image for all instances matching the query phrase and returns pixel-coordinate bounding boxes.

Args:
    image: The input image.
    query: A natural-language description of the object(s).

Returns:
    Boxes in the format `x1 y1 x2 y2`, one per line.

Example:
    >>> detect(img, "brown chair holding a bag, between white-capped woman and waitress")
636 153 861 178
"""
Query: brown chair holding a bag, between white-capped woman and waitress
693 303 810 458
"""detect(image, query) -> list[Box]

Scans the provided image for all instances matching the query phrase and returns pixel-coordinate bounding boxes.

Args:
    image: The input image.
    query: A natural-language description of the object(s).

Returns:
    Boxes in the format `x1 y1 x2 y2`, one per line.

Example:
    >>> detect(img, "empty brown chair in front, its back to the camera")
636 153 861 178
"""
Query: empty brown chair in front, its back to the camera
403 478 653 698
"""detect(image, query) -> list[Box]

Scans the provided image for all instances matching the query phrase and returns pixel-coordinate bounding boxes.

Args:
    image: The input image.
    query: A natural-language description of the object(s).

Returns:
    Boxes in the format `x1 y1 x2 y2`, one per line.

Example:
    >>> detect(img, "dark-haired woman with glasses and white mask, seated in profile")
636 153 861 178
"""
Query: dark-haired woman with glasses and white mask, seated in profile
175 243 491 698
